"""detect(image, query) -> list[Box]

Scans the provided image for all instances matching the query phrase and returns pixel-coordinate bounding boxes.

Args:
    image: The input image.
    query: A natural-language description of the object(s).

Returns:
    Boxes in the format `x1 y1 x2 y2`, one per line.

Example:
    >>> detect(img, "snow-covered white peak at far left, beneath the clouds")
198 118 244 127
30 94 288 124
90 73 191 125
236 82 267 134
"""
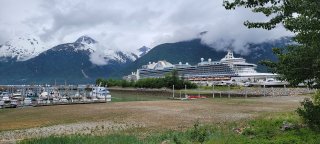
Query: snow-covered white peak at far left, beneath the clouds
0 35 47 61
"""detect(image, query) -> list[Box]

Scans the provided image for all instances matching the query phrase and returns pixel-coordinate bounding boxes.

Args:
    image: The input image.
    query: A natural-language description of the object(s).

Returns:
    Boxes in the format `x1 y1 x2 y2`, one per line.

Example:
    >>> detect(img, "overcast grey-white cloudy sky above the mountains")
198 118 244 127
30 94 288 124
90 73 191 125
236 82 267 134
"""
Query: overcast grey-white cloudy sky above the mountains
0 0 290 53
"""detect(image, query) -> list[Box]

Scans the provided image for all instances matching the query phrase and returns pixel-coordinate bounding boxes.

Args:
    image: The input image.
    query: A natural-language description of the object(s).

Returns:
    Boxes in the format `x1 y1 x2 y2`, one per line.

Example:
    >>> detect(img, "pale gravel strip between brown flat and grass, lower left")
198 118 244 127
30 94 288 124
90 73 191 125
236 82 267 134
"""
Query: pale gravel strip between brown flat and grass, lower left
0 121 145 143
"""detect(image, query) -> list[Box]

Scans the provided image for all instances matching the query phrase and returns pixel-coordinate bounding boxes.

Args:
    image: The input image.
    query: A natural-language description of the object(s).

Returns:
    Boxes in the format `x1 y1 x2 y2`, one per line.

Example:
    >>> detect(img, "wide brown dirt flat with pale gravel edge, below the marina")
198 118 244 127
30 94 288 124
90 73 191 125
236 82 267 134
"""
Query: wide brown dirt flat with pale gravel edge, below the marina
0 96 304 143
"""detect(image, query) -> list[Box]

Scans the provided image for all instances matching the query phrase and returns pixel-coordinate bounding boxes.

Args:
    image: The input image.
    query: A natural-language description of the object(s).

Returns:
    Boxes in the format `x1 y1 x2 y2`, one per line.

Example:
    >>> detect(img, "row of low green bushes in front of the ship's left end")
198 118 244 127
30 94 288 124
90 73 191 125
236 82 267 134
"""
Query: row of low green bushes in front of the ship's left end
96 70 197 89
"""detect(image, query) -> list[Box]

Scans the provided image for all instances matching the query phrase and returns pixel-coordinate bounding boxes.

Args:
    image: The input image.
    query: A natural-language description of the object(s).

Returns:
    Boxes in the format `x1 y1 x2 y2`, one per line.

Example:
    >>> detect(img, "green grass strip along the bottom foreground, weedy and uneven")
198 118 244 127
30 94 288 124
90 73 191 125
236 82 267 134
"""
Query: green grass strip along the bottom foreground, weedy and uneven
21 113 320 144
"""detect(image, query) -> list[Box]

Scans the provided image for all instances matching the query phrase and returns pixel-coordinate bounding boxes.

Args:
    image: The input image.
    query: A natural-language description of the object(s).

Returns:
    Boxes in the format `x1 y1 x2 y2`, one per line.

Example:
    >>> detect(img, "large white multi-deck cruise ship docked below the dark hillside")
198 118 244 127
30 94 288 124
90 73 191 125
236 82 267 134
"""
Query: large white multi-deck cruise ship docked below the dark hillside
125 50 277 82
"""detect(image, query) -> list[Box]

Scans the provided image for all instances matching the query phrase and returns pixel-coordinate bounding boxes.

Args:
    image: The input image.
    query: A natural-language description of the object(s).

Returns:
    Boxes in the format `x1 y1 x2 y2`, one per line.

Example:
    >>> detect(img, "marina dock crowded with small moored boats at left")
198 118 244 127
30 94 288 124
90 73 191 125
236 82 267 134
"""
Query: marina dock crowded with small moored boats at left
0 85 111 108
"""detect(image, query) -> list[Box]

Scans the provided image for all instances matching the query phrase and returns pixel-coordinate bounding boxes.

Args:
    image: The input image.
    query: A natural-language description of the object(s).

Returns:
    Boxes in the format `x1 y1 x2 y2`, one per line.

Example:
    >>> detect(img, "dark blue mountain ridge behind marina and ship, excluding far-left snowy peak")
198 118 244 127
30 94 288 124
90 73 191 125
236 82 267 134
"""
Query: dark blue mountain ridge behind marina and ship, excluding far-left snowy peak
0 37 290 84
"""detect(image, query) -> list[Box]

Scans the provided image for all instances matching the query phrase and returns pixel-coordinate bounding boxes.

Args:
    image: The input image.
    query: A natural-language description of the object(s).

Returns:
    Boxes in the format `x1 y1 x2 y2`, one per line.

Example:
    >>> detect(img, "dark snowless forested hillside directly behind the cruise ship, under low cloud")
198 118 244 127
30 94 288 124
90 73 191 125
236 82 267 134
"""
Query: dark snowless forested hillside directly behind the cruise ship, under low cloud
122 37 291 75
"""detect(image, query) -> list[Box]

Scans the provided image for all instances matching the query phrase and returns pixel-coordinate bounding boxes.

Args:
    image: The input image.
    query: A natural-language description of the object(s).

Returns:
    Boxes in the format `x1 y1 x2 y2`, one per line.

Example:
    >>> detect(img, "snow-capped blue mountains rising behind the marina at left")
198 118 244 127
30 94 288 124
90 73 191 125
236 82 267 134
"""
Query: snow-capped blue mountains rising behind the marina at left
0 36 152 84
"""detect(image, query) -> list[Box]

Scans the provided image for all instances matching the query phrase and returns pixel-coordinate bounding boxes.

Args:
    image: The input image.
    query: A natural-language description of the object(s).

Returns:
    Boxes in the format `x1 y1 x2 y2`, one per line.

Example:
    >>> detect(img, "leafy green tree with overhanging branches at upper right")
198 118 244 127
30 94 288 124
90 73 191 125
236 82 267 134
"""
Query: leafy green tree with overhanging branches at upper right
224 0 320 86
